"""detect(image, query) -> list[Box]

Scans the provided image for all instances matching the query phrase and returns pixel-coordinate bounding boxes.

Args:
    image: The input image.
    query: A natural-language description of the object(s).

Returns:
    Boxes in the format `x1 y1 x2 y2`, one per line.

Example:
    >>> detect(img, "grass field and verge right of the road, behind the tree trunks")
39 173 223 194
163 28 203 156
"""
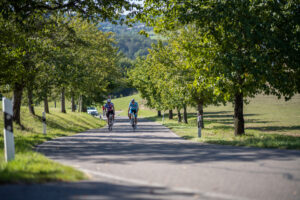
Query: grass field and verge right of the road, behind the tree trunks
114 95 300 149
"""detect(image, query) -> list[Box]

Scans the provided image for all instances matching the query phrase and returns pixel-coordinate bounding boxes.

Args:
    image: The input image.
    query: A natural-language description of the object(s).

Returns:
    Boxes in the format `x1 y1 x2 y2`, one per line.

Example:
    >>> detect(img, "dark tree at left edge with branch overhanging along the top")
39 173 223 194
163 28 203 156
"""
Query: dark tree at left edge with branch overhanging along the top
0 0 139 124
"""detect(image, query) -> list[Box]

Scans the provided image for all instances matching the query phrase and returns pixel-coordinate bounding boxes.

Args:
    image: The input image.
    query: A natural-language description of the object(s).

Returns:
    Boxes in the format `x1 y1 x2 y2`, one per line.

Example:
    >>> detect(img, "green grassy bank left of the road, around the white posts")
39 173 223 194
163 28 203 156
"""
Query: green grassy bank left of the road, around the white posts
0 102 105 184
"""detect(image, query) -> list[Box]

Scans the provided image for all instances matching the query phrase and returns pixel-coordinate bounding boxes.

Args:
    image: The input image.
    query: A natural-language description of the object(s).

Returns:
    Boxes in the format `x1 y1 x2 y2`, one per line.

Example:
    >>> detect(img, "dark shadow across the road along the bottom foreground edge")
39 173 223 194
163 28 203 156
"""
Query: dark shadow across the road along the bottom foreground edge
0 182 200 200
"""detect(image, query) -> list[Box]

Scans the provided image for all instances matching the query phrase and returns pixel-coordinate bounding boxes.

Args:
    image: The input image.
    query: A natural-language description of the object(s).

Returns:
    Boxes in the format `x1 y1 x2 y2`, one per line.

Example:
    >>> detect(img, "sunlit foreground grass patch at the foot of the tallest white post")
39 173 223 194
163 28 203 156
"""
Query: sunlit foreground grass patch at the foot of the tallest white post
0 151 86 183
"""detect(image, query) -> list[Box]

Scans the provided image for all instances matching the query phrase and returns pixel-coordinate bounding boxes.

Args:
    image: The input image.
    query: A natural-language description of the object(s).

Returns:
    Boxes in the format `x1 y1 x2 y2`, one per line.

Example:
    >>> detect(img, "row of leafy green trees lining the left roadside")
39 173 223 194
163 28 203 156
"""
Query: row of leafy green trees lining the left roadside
0 0 142 124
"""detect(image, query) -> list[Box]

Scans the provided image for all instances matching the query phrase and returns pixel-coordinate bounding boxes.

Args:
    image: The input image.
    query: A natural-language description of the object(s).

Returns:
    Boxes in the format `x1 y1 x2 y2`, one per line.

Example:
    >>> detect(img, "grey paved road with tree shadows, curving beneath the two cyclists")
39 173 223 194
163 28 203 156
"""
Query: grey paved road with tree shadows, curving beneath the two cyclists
0 118 300 200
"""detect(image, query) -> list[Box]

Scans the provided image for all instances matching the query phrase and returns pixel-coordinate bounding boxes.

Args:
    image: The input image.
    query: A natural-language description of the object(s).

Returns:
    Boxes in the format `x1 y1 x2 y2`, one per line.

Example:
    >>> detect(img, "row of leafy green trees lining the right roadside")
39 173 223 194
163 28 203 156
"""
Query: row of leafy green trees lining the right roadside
128 0 300 135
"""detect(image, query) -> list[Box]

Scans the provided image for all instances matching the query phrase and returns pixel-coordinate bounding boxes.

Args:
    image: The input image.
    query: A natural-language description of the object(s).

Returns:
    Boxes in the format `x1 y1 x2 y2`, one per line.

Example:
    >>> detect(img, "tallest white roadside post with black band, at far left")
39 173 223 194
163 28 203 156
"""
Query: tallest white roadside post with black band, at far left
2 97 15 162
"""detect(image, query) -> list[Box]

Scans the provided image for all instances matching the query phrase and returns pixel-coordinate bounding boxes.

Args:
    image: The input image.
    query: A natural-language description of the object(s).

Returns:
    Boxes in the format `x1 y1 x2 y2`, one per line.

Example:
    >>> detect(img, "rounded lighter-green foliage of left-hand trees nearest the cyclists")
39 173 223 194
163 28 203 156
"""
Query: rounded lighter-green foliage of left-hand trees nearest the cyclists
39 17 120 112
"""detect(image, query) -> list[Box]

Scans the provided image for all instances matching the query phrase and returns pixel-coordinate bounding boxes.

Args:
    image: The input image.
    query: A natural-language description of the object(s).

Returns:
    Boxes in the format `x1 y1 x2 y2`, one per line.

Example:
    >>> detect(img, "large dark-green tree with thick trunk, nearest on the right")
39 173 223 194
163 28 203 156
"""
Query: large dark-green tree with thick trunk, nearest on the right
138 0 300 135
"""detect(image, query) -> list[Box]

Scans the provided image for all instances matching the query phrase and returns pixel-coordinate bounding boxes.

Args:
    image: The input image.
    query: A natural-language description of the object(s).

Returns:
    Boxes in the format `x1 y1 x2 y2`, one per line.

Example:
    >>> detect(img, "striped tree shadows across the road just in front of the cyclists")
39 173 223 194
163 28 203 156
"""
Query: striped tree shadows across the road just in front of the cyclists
39 121 300 164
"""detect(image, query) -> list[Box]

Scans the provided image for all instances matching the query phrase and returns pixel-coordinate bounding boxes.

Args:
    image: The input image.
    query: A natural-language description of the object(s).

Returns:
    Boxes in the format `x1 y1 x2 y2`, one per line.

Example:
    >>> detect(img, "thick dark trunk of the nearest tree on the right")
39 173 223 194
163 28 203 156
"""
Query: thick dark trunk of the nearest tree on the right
234 92 245 135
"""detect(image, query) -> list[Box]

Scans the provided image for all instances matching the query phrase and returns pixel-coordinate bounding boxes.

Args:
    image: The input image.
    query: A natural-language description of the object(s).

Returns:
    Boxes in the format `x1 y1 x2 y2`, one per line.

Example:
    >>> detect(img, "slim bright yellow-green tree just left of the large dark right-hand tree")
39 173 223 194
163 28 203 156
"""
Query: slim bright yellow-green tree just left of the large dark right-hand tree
168 24 226 128
